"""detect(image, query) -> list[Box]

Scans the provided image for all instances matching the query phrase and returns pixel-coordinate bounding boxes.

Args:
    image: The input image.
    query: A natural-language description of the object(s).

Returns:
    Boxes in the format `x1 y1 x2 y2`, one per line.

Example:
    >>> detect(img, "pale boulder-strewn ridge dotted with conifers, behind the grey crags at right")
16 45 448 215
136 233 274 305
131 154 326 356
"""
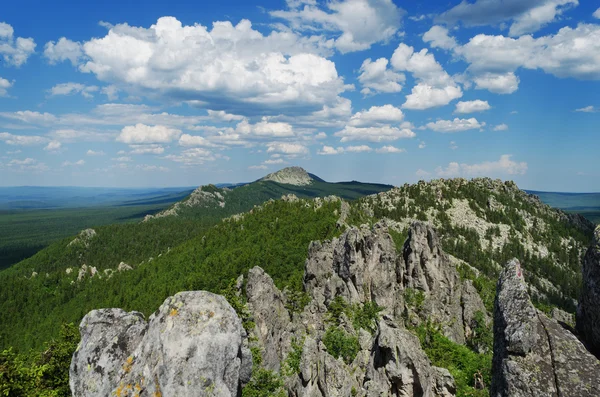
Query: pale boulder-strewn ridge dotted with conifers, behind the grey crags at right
354 178 594 310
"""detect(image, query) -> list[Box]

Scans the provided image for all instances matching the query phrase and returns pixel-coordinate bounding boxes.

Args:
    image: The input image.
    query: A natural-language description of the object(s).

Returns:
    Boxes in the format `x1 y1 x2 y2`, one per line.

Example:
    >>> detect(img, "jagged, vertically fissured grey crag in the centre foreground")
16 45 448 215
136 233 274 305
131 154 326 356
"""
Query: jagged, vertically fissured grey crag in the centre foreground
241 223 485 397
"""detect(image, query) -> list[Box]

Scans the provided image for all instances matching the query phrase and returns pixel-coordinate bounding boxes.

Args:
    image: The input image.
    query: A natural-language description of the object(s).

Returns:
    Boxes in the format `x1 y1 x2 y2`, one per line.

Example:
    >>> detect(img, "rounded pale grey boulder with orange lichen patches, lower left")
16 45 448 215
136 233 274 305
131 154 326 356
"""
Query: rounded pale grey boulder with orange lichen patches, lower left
69 291 252 397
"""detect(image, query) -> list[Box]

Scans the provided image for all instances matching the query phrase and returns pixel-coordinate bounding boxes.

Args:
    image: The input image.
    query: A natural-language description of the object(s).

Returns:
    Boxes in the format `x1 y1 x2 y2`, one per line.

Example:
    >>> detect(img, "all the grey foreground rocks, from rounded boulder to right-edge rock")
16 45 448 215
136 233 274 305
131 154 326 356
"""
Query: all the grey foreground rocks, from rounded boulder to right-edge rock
70 222 600 397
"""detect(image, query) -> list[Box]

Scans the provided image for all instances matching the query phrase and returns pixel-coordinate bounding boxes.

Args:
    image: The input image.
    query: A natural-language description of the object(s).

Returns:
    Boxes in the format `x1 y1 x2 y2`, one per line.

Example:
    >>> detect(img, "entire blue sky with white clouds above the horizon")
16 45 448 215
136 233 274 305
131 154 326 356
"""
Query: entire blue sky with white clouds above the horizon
0 0 600 192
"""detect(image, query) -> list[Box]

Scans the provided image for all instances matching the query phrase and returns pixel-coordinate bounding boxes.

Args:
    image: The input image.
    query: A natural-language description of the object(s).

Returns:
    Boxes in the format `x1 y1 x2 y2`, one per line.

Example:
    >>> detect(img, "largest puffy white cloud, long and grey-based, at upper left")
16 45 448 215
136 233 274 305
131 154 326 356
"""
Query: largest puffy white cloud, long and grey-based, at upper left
52 17 350 114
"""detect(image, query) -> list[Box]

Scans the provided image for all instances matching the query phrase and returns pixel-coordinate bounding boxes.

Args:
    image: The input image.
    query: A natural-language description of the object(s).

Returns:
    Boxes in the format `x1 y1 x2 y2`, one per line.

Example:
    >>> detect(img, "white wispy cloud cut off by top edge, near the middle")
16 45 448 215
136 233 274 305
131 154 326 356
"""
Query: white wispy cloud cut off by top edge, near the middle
270 0 404 53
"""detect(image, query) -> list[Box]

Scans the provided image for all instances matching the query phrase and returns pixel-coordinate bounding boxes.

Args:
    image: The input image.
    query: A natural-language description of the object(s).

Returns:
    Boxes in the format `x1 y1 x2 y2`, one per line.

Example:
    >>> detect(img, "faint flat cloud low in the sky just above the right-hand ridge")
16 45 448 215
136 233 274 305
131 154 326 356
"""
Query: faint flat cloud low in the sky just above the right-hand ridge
435 154 527 178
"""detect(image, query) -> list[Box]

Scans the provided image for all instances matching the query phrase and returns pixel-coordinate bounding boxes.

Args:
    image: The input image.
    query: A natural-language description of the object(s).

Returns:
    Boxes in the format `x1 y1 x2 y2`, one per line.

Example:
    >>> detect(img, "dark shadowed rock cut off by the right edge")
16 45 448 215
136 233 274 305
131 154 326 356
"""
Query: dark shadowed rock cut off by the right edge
577 226 600 356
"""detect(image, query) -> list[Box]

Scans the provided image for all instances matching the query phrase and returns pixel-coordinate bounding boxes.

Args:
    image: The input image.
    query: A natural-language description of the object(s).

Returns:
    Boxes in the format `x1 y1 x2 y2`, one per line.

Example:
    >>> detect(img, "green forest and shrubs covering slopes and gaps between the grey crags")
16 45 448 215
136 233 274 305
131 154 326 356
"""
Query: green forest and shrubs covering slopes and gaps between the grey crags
0 181 591 396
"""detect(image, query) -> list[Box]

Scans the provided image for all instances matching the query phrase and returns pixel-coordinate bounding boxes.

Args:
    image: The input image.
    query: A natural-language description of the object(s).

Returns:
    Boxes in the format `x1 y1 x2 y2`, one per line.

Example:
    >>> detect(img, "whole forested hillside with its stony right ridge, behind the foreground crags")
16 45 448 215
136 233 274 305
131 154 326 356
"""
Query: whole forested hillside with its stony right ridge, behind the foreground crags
0 178 593 396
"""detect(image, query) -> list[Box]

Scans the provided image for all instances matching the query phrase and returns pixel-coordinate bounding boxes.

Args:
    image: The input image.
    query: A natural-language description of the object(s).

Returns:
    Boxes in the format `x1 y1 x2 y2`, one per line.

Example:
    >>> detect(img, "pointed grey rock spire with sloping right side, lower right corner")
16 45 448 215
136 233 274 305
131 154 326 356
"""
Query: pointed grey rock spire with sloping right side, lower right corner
491 259 600 397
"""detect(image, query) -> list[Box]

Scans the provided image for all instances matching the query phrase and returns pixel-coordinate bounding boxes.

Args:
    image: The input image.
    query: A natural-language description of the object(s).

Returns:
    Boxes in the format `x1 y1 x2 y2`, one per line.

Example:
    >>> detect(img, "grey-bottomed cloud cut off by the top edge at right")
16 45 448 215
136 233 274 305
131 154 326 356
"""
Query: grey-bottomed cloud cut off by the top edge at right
436 0 579 36
